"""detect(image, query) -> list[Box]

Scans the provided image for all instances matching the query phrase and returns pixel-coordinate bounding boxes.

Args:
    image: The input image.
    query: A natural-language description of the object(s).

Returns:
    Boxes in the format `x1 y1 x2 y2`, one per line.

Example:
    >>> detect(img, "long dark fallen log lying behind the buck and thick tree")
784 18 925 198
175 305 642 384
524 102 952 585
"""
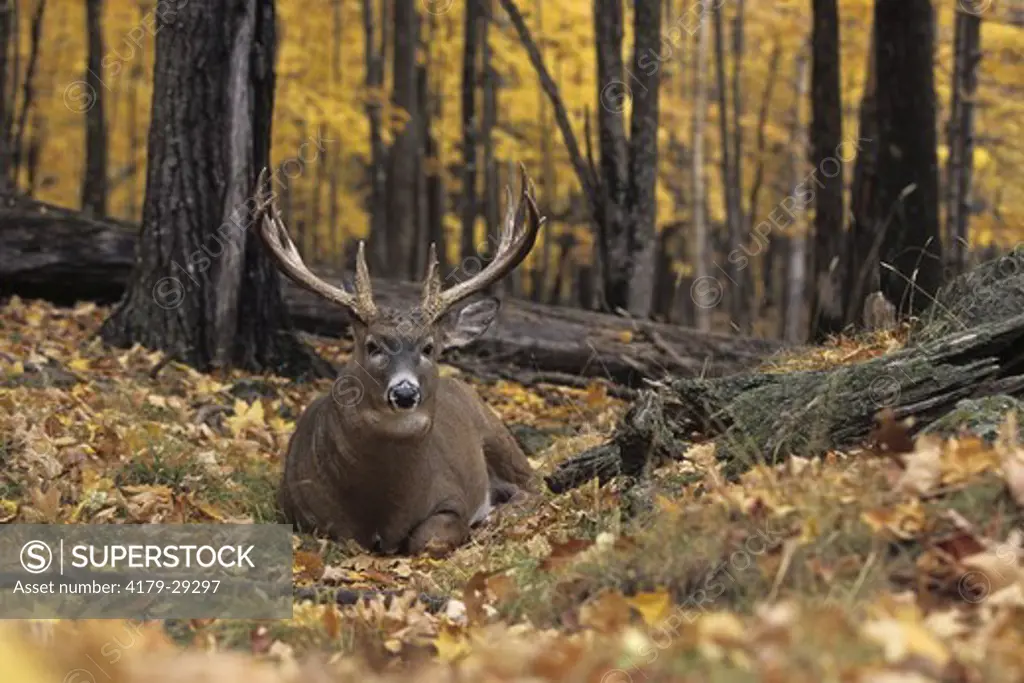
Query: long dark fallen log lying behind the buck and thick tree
0 200 781 387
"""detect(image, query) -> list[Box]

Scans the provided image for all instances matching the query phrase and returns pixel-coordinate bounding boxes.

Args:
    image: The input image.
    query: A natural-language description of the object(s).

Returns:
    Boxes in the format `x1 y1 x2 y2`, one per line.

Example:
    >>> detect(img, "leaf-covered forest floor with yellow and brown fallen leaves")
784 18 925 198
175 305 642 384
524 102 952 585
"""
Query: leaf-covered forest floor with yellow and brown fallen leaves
0 299 1024 683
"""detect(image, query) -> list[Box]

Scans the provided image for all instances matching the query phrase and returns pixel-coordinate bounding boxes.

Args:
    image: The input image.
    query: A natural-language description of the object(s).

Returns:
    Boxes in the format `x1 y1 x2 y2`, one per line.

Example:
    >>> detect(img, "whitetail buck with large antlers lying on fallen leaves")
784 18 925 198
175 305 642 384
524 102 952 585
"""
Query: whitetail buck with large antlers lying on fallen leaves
257 169 544 555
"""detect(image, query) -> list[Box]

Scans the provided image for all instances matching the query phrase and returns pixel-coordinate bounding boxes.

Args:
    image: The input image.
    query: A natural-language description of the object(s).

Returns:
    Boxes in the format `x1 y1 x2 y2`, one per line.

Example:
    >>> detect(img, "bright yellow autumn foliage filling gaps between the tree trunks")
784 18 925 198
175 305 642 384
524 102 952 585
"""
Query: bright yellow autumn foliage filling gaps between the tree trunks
12 0 1024 256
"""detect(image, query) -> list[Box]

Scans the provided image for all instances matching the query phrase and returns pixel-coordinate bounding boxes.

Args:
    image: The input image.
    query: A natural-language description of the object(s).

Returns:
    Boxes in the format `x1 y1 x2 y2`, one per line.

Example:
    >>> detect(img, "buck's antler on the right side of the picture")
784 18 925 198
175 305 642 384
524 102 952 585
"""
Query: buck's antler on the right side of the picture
421 164 544 322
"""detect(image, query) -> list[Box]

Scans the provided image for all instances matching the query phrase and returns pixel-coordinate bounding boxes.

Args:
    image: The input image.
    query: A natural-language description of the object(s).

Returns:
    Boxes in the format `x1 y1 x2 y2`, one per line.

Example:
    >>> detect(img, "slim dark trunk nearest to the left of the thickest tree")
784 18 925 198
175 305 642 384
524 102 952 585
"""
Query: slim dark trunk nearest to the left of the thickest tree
82 0 106 218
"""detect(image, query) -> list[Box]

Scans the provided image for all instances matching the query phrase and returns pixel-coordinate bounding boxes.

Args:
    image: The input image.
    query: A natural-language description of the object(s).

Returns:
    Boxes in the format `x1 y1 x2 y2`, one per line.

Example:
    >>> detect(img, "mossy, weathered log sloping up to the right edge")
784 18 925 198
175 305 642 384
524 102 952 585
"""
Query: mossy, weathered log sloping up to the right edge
548 314 1024 493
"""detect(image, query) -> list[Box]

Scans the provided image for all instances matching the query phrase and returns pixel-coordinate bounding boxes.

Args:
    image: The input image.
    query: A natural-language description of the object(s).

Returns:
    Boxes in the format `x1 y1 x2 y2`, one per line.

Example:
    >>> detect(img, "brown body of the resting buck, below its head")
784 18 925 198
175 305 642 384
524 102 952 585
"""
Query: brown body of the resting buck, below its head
279 370 532 554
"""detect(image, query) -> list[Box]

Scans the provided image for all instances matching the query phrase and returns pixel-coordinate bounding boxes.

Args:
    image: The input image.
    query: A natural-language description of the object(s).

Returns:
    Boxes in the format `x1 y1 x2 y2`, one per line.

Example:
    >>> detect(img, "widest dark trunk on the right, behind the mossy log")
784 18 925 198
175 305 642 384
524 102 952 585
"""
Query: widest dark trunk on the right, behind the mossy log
874 0 942 315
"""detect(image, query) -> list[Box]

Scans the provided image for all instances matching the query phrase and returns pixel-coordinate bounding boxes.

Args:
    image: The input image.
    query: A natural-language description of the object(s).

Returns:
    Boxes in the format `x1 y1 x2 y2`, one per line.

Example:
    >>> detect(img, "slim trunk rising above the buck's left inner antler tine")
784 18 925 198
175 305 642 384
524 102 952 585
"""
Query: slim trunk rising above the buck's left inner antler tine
362 0 388 272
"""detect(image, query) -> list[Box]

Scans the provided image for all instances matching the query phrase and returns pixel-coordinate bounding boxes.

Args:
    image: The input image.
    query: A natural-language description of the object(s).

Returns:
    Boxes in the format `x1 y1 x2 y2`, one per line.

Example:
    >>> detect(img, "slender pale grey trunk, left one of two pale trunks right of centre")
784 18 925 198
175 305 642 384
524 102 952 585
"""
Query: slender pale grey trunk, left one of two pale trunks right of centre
687 7 721 332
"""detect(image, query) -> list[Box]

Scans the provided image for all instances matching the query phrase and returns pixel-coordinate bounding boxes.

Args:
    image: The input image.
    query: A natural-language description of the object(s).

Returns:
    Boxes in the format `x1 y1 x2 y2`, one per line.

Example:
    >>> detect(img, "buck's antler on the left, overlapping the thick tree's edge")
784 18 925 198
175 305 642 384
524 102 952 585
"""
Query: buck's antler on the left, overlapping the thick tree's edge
255 168 377 324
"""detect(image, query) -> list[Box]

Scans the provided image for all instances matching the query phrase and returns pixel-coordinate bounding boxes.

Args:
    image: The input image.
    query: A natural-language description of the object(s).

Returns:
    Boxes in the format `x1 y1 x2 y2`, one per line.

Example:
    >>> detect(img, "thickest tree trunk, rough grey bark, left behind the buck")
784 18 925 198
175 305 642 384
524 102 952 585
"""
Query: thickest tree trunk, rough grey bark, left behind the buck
100 0 327 375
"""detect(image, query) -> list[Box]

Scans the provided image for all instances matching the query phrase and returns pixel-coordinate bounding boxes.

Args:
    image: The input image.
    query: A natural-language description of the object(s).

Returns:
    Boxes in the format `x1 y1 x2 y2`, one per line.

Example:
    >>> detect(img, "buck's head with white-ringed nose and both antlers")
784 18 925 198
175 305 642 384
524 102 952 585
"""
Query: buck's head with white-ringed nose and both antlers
257 168 544 437
